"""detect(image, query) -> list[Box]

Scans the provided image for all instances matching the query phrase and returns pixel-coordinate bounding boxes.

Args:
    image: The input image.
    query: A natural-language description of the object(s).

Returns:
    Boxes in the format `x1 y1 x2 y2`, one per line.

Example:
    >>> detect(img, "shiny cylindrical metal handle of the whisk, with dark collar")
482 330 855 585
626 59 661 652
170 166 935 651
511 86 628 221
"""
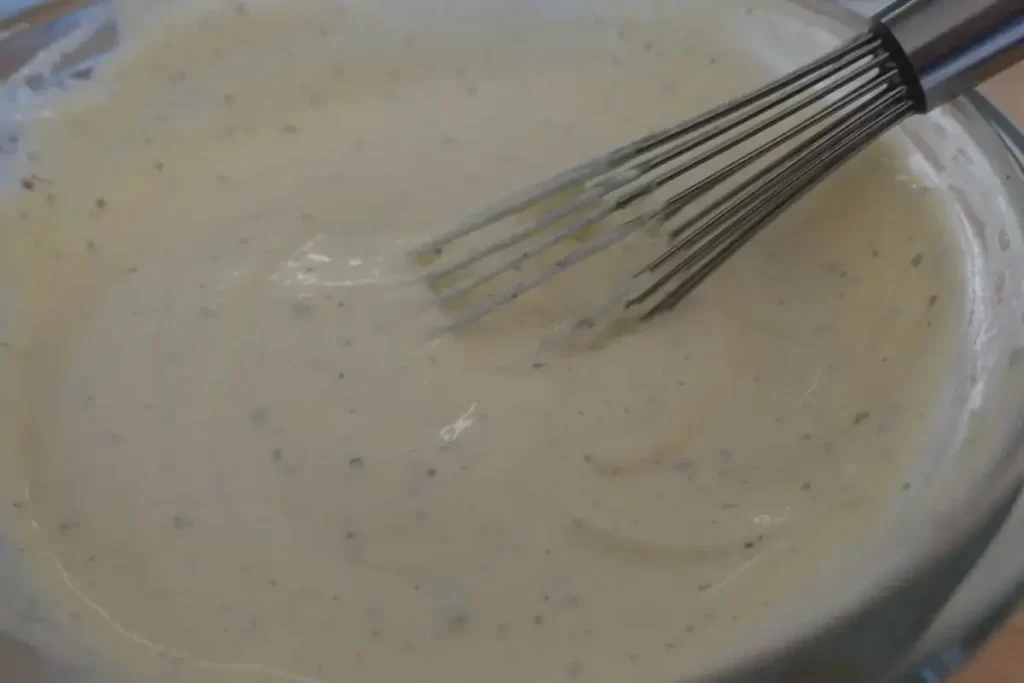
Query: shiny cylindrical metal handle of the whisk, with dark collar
873 0 1024 112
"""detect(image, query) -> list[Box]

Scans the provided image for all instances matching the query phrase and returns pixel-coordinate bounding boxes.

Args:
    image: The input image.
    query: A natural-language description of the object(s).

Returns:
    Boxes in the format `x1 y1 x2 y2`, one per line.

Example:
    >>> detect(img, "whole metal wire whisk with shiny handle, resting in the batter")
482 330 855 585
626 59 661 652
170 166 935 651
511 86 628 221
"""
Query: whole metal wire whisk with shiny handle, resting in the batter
413 0 1024 330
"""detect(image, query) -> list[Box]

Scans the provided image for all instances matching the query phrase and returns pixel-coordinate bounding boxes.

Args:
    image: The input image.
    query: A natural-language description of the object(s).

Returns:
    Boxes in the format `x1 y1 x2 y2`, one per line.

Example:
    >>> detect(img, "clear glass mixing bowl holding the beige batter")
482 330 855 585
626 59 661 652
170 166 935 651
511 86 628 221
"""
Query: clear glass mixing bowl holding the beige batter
0 0 1024 683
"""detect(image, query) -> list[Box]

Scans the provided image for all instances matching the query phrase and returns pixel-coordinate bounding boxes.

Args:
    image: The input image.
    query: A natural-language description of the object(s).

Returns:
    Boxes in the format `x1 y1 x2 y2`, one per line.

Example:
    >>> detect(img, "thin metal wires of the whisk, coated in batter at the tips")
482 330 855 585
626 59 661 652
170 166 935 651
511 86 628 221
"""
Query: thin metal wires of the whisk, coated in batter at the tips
413 33 912 330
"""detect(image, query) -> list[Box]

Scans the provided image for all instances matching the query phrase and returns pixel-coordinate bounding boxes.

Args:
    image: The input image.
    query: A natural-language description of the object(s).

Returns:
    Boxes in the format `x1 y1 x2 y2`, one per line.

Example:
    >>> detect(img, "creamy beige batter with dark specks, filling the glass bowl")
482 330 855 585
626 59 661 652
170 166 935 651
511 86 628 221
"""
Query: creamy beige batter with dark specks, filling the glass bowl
0 0 964 683
